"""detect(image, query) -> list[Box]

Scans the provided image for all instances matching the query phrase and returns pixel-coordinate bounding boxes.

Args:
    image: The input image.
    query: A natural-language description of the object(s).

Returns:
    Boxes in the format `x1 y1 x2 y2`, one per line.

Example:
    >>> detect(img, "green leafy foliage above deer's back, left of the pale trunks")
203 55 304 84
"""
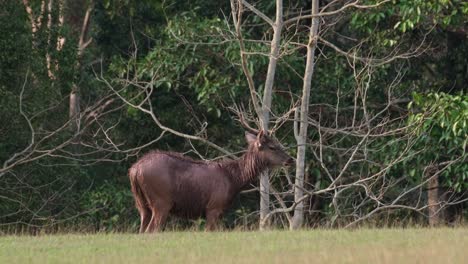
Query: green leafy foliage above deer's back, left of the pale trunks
124 12 265 113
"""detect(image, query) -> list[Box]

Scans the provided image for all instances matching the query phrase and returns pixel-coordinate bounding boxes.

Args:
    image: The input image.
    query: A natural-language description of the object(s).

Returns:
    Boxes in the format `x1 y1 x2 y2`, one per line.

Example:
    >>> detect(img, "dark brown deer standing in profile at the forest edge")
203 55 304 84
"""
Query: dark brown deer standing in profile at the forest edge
128 132 294 233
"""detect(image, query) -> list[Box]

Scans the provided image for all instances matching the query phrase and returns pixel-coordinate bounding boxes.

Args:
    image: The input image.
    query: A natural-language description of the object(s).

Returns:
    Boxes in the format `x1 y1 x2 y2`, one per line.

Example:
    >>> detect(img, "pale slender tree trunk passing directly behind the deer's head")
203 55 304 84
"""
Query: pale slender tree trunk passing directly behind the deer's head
260 0 283 230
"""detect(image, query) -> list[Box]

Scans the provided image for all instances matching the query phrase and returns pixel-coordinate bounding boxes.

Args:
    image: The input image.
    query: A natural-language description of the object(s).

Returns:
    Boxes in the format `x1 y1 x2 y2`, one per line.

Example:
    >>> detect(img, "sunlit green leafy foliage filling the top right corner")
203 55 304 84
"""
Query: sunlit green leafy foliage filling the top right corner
349 0 468 93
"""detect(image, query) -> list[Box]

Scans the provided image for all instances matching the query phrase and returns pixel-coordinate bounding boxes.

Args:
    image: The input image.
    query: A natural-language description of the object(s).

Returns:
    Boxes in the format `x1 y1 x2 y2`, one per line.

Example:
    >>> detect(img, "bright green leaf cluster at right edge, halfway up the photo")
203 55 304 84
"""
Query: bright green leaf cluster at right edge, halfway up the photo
408 93 468 192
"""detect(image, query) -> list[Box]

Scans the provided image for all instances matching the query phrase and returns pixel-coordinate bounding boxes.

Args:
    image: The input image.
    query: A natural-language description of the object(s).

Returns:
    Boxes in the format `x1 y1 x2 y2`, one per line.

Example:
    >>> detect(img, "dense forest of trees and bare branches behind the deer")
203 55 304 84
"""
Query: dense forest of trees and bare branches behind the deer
0 0 468 232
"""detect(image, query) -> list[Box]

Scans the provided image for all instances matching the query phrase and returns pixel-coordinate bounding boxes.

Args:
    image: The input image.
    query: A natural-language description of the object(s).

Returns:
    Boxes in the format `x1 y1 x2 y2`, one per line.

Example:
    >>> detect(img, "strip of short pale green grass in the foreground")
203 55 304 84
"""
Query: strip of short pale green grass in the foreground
0 228 468 264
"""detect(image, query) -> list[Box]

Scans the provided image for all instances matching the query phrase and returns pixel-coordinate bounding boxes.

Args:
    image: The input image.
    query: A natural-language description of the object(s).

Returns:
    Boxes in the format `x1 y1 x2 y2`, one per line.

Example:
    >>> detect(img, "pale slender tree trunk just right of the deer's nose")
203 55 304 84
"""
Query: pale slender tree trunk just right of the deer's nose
289 0 320 229
